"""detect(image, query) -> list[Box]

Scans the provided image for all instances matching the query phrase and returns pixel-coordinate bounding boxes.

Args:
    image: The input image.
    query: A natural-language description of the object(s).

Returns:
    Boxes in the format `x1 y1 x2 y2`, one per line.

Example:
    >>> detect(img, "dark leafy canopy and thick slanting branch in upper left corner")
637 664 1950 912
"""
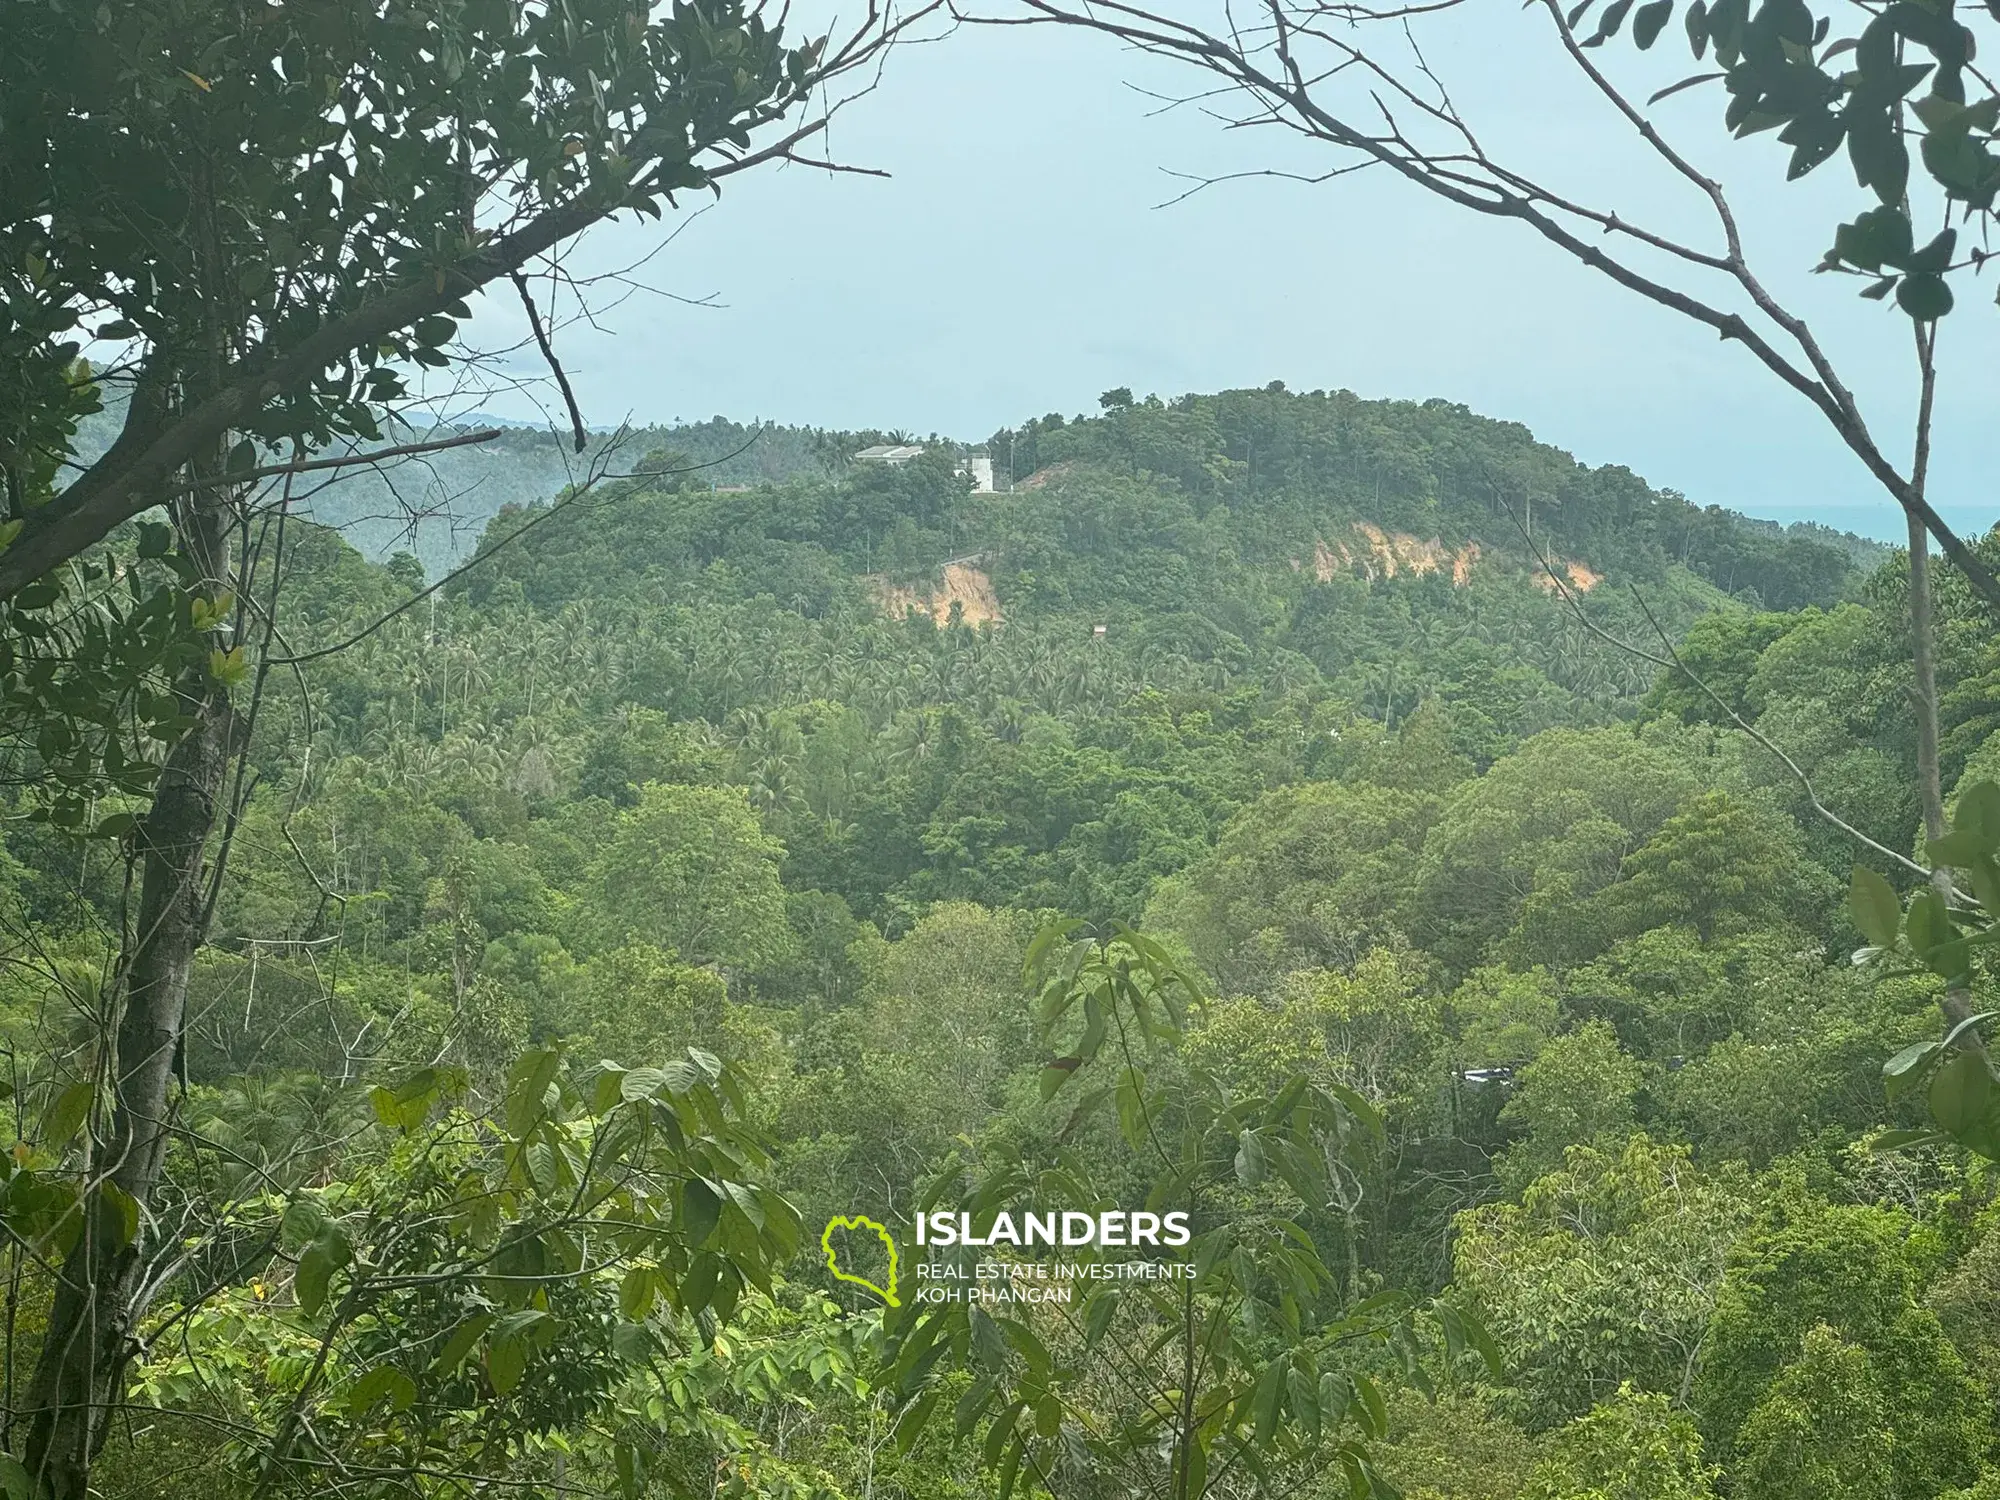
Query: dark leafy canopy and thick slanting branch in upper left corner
0 0 920 600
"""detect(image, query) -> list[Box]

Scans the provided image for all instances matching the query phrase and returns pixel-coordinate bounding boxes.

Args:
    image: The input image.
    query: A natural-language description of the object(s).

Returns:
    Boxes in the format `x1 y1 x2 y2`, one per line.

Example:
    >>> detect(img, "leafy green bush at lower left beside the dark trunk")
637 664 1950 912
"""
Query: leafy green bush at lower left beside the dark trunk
0 1050 812 1498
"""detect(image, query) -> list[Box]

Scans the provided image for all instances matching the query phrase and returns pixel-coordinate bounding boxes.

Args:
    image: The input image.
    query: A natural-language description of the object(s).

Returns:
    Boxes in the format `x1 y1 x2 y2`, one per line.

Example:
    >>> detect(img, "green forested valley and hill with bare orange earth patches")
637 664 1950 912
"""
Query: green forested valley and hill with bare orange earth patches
0 386 2000 1500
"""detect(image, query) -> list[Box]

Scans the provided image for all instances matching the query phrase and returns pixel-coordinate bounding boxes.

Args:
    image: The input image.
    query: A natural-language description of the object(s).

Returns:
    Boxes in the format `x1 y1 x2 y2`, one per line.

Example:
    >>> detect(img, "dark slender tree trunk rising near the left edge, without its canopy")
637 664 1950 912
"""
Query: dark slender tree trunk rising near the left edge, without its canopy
16 492 234 1500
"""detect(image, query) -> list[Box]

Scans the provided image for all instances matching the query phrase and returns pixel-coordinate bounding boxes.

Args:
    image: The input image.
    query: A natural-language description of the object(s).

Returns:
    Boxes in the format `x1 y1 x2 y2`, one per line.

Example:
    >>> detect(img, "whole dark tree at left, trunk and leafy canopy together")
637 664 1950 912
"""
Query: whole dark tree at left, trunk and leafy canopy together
0 0 924 1500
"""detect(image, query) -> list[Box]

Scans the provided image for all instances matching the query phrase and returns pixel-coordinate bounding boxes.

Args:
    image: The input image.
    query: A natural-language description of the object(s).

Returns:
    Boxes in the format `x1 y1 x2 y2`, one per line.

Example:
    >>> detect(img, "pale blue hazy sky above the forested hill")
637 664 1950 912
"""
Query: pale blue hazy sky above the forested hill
458 0 2000 540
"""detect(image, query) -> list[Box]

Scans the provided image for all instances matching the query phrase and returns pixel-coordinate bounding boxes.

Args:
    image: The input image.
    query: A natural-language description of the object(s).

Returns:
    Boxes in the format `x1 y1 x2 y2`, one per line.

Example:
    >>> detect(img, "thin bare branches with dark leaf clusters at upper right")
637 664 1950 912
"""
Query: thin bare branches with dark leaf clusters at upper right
986 0 2000 616
